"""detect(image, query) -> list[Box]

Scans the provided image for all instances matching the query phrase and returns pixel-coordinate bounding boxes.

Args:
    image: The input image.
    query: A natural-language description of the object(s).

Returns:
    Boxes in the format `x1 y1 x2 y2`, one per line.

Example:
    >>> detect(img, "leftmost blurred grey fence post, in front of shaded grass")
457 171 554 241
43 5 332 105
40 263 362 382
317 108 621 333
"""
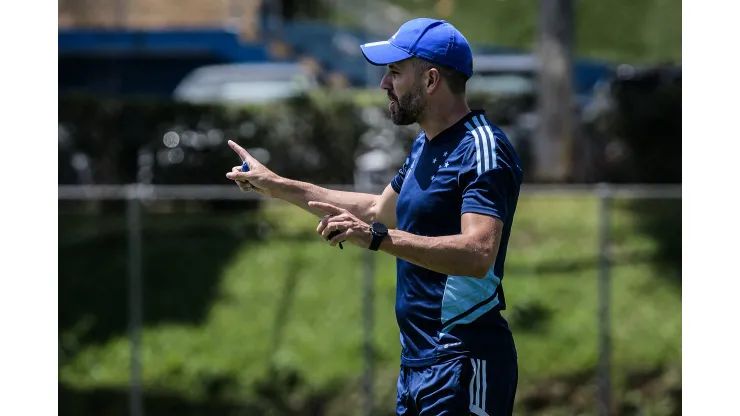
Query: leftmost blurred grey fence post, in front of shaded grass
126 186 144 416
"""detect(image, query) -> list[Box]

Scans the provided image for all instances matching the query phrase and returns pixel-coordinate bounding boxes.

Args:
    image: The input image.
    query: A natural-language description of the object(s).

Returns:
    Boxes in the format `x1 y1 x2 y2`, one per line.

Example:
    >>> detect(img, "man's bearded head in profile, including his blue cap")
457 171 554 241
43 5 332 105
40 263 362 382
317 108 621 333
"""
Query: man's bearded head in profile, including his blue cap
361 18 473 125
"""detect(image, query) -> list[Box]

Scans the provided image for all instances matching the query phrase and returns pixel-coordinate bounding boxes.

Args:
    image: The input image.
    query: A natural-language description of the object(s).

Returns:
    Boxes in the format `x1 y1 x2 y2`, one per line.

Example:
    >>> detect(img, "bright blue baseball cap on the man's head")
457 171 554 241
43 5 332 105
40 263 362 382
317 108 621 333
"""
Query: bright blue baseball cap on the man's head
360 18 473 78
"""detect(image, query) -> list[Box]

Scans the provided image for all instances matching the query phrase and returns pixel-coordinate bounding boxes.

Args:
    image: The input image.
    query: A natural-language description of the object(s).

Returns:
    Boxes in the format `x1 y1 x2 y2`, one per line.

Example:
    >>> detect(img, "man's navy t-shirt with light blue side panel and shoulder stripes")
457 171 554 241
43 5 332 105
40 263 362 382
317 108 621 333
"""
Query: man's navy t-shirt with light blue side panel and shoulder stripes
391 111 522 366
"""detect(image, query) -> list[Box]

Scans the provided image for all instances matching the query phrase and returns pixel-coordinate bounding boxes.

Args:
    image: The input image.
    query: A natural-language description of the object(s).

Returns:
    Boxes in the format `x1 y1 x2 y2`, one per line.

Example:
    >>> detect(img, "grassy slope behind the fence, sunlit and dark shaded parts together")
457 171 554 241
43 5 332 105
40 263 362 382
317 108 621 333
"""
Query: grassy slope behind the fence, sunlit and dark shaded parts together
59 196 681 415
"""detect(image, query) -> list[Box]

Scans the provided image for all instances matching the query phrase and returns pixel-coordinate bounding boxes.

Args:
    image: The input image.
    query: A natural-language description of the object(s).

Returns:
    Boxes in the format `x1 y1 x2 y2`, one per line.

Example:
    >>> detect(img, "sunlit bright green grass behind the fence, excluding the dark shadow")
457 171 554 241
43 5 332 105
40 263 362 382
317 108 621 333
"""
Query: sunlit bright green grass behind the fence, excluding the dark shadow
59 196 681 410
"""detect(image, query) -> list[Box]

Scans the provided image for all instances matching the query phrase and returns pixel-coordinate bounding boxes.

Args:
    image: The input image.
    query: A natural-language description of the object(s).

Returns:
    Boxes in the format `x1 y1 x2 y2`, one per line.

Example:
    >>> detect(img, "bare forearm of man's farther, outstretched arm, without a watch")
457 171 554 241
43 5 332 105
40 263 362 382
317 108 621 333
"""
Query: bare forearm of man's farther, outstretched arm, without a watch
272 178 376 222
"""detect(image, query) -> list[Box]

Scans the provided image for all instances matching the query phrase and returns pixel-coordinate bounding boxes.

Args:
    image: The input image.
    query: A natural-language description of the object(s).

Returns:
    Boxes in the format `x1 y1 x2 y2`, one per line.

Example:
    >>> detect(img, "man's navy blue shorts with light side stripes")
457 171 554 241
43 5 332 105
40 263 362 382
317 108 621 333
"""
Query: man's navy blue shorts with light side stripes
396 353 519 416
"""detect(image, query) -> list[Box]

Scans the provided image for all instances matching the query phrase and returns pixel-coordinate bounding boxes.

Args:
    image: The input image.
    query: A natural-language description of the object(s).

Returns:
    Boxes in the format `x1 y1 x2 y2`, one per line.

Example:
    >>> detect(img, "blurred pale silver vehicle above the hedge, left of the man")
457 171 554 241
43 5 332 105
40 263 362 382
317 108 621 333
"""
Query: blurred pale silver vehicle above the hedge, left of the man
173 63 319 104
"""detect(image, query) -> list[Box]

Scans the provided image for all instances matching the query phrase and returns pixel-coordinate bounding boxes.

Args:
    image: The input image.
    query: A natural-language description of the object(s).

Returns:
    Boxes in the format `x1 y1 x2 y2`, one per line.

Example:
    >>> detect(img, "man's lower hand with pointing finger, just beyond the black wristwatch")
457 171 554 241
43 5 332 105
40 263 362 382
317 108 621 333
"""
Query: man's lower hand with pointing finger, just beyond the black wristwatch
308 201 373 248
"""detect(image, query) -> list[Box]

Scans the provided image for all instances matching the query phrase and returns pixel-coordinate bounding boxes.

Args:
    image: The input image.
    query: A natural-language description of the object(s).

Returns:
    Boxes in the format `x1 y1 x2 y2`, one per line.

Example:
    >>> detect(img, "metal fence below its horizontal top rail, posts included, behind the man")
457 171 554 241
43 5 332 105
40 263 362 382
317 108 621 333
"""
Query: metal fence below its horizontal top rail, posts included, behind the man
59 186 681 416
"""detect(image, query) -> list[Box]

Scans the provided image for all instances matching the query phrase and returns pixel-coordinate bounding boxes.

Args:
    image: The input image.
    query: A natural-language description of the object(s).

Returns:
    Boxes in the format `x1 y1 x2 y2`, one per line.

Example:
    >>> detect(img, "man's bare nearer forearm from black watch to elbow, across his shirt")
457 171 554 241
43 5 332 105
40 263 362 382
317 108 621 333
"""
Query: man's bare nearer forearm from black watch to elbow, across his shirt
380 230 495 278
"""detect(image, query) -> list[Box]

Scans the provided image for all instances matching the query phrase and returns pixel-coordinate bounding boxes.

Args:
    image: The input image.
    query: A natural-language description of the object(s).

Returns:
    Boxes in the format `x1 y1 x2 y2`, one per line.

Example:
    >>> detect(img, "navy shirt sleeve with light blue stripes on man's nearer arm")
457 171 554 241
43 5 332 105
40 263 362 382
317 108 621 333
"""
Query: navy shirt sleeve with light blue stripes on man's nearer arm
458 139 514 222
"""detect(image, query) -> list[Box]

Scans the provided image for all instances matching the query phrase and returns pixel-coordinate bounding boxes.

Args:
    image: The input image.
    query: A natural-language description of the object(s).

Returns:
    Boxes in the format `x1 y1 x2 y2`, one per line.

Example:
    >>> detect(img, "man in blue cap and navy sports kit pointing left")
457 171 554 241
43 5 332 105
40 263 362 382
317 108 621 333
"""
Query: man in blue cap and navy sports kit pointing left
226 19 522 416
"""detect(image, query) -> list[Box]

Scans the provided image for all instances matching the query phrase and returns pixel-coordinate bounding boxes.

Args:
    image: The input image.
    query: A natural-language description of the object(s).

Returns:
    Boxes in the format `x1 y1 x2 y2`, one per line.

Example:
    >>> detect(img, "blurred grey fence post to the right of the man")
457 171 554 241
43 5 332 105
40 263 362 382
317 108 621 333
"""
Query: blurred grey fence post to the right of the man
596 184 612 416
